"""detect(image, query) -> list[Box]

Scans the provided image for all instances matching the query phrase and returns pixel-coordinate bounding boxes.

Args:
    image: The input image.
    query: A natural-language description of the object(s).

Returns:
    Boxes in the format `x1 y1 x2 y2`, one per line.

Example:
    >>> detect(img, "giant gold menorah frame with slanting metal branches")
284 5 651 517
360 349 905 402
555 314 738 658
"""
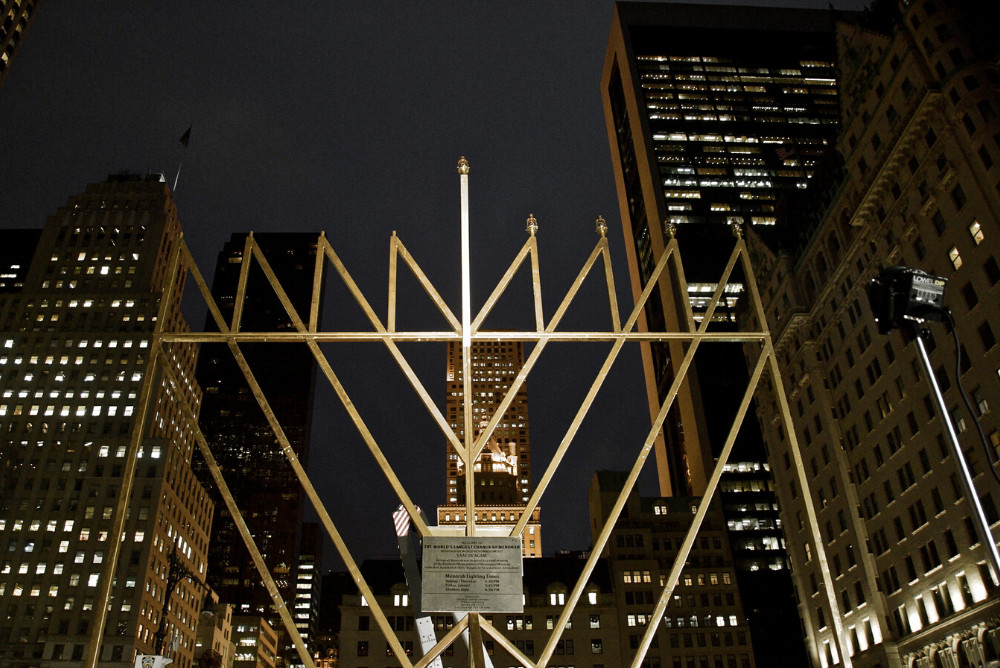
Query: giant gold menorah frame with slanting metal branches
86 166 851 668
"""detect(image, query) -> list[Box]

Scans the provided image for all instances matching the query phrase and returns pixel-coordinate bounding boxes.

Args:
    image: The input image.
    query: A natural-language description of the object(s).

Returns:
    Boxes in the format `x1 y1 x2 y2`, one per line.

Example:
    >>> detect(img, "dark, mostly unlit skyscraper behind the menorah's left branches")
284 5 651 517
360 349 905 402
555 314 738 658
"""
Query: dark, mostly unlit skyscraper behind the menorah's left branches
195 233 318 647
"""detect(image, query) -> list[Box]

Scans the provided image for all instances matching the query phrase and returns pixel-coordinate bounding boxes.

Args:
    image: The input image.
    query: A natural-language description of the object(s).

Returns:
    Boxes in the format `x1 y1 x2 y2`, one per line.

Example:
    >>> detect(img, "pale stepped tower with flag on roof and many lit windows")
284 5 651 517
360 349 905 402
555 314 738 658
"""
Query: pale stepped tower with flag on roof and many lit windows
0 174 212 668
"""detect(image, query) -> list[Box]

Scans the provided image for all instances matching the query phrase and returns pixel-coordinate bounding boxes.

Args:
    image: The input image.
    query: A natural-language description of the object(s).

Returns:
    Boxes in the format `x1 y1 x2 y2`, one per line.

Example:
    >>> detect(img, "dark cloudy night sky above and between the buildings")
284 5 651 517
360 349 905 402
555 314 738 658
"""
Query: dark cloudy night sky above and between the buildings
0 0 860 563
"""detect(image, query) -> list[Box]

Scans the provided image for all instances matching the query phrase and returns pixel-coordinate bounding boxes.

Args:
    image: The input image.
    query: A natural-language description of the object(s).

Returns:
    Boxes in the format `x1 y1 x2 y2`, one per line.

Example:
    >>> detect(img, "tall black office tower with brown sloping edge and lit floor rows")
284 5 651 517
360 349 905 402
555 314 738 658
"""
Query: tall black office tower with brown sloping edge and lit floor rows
602 3 840 665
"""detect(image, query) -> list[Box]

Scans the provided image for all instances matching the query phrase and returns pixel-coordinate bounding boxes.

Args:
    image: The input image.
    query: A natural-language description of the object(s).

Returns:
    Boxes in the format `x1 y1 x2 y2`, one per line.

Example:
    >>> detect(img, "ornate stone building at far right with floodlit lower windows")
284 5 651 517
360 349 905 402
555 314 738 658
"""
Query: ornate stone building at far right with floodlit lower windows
749 0 1000 668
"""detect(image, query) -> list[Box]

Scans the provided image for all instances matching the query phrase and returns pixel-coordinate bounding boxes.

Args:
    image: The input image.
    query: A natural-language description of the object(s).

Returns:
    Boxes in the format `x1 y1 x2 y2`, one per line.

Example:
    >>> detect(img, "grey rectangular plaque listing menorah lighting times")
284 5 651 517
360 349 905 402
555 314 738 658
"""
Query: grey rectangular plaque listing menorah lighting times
421 536 524 612
